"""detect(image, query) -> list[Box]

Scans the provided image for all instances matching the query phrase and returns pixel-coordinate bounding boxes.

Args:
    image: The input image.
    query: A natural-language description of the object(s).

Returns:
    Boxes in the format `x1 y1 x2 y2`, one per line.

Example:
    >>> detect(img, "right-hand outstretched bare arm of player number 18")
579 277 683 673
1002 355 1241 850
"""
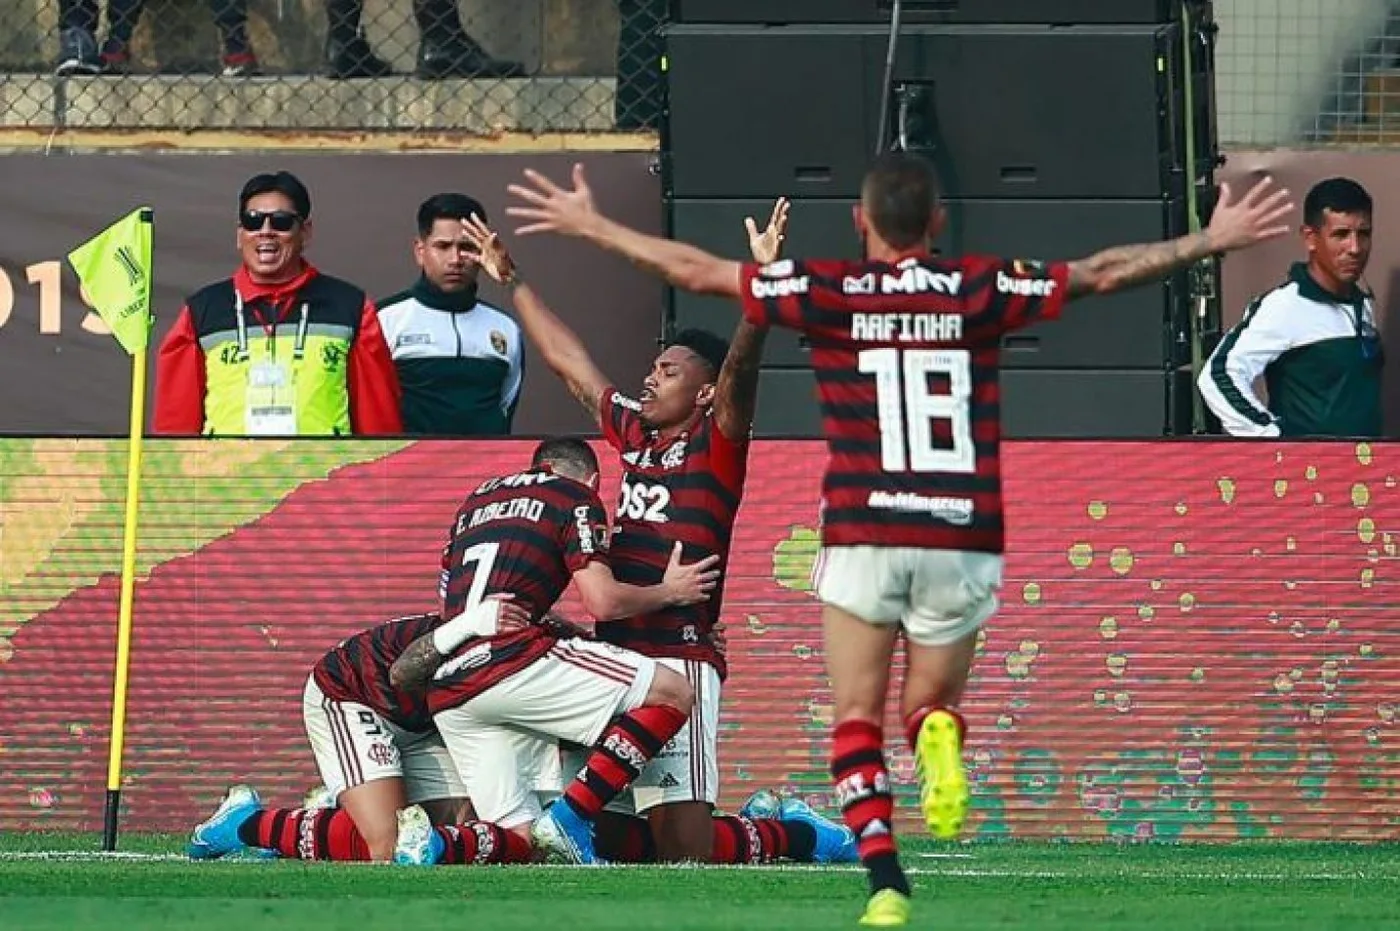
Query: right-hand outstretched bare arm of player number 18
1068 178 1294 298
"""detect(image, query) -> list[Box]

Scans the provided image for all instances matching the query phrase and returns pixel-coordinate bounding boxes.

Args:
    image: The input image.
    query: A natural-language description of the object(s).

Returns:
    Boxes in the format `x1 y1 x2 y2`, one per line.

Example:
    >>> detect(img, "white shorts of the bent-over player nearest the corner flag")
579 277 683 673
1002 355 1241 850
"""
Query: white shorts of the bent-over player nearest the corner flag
301 676 466 802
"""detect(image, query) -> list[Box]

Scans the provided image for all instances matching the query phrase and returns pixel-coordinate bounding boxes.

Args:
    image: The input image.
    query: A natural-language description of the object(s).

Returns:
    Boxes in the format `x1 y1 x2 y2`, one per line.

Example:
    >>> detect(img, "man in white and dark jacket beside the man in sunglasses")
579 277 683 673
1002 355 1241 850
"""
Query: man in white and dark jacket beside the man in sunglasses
379 193 525 437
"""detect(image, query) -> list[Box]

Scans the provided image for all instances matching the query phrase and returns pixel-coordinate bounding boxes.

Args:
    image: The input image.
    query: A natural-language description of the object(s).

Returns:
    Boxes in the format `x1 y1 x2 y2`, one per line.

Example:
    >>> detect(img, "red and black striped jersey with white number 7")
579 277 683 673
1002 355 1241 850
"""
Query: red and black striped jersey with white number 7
428 470 609 714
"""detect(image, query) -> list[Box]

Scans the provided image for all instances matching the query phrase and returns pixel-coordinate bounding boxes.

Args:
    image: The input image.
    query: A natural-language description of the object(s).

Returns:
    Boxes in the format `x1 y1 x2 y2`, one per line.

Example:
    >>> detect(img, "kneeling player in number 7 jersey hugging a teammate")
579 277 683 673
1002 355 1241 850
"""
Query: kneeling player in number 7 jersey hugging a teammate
391 440 720 862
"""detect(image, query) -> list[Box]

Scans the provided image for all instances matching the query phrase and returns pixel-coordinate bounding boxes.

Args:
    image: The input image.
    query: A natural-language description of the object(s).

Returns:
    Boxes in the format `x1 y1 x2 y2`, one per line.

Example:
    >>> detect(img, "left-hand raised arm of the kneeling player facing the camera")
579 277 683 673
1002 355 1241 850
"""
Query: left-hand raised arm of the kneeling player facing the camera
462 217 610 423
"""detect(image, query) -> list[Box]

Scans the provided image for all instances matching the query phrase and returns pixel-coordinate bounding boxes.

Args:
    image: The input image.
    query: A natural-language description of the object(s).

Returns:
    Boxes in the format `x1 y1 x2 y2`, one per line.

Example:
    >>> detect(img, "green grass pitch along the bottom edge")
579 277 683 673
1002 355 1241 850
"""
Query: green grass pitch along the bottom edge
0 834 1400 931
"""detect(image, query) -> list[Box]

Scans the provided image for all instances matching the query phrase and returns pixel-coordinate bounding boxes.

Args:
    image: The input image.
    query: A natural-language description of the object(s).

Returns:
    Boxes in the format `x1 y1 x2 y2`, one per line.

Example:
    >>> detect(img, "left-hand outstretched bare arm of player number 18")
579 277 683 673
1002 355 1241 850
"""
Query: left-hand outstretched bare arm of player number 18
505 165 739 297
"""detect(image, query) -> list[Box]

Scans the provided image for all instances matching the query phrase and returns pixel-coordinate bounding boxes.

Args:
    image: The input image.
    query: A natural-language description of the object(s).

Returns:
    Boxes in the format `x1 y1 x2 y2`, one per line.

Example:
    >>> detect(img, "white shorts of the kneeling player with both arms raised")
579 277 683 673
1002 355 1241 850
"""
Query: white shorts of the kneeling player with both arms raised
564 659 720 815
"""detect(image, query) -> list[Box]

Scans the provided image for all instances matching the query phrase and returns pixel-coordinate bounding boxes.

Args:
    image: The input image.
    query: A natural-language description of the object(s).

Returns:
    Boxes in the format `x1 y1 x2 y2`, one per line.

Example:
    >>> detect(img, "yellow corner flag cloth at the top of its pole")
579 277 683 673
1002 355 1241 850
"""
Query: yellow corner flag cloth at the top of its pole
69 207 154 356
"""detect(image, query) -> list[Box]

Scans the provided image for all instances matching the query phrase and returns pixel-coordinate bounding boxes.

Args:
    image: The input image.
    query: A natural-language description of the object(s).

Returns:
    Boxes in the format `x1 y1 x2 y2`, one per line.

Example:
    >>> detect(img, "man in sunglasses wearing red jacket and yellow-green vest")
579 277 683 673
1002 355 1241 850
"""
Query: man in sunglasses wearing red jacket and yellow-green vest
155 171 403 437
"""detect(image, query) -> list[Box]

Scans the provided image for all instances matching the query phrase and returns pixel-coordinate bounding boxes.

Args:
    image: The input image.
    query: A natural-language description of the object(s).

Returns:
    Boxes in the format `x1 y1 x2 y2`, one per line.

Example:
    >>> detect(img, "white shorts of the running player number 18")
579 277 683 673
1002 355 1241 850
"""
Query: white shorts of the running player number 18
812 546 1004 647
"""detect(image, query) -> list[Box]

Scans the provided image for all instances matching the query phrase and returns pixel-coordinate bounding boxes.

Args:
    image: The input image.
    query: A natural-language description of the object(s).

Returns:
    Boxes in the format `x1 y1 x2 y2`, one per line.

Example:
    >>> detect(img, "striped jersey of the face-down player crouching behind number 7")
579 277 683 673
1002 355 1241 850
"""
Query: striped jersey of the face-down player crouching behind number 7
311 615 441 734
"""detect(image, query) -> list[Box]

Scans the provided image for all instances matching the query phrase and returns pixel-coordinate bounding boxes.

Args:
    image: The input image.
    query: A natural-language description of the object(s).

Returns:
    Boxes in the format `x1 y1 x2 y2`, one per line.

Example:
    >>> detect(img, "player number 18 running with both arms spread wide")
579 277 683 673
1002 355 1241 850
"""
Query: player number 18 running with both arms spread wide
507 153 1292 927
